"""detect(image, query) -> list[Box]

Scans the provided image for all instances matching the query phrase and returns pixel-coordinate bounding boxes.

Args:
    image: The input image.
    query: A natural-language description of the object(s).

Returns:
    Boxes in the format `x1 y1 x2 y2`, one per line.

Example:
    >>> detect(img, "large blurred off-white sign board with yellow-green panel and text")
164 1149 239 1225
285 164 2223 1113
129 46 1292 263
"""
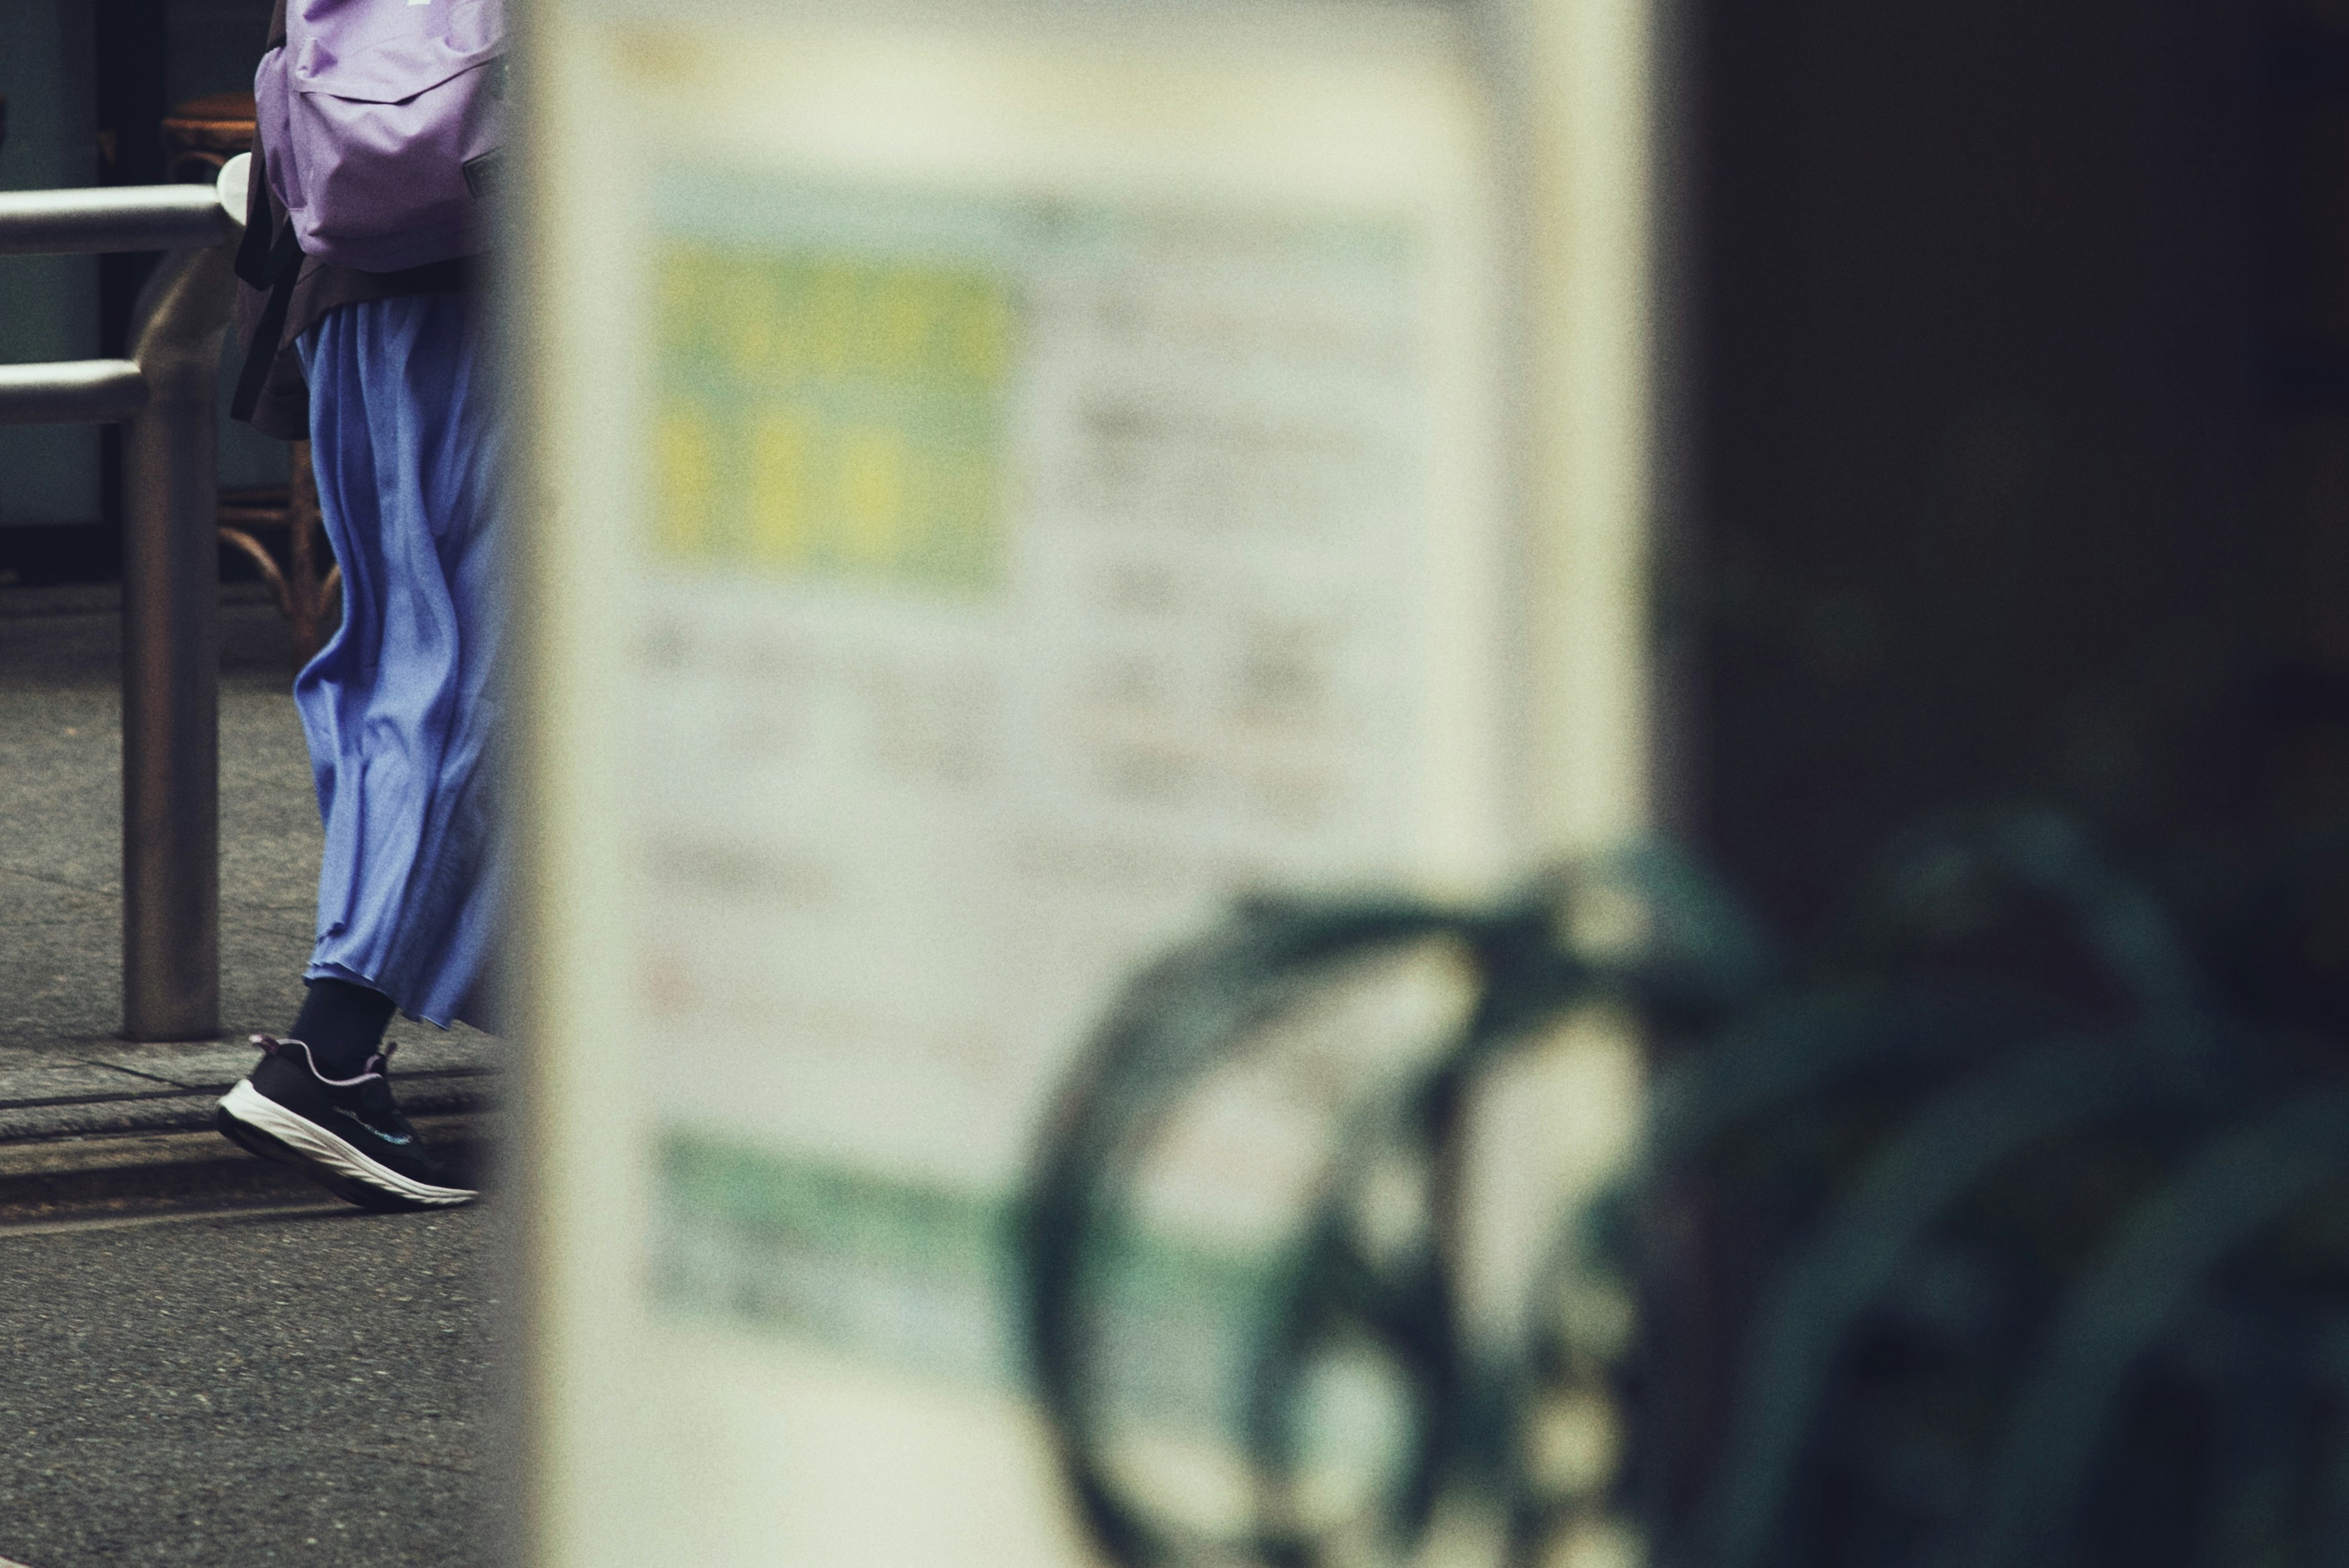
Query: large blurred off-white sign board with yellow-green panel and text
521 0 1559 1568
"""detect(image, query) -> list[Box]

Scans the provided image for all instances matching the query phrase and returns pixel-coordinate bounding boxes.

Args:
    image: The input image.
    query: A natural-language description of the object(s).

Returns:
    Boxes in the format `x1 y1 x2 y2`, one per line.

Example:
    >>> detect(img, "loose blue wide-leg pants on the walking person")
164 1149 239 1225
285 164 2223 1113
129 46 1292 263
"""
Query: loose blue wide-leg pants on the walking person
294 294 505 1027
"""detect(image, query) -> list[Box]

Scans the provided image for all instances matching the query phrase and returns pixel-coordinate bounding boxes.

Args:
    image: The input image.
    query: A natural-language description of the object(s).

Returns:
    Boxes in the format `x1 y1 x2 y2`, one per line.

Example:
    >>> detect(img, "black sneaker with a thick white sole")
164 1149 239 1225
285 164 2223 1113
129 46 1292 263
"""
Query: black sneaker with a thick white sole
212 1035 479 1208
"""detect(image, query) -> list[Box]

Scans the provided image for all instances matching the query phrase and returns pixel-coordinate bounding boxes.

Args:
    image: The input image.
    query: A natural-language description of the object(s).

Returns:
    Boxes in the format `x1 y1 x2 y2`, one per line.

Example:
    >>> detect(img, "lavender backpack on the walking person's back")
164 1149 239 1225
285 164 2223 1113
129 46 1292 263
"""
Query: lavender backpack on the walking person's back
254 0 505 273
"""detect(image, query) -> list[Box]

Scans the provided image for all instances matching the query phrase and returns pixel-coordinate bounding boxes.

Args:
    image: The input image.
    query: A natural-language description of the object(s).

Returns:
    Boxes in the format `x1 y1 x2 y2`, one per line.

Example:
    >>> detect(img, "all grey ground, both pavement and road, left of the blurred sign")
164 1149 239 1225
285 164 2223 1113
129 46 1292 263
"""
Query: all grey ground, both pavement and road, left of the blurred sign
0 588 503 1568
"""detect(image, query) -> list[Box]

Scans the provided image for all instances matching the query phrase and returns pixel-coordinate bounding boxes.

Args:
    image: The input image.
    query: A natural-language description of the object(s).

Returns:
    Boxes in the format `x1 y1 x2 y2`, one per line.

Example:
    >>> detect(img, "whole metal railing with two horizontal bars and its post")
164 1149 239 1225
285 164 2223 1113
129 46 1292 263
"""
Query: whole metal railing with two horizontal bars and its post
0 157 249 1039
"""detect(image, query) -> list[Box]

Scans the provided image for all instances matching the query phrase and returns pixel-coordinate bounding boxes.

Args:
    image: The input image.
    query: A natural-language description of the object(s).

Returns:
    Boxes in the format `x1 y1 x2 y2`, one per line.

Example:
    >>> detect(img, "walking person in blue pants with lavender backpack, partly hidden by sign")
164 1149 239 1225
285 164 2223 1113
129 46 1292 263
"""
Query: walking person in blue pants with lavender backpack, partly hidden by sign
213 0 505 1208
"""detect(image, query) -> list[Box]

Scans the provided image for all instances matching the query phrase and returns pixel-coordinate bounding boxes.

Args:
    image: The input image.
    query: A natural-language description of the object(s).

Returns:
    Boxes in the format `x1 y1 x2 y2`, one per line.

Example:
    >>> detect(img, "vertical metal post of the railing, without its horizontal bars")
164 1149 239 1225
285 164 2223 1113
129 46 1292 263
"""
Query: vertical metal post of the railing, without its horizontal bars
122 245 235 1039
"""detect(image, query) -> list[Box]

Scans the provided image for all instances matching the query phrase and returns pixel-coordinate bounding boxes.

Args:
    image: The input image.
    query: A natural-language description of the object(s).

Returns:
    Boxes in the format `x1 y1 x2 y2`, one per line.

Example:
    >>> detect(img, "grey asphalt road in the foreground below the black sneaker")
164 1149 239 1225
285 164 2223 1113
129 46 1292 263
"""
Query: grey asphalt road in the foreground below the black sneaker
0 1208 503 1568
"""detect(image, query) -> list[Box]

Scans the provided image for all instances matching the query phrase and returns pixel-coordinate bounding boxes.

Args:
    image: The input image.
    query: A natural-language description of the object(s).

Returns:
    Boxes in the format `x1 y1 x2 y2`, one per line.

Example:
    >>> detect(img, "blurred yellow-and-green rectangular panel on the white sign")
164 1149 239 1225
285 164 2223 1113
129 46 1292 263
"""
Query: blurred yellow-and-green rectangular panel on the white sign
651 245 1012 595
